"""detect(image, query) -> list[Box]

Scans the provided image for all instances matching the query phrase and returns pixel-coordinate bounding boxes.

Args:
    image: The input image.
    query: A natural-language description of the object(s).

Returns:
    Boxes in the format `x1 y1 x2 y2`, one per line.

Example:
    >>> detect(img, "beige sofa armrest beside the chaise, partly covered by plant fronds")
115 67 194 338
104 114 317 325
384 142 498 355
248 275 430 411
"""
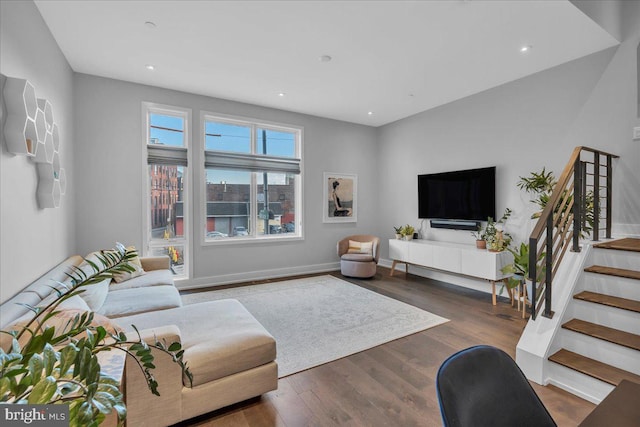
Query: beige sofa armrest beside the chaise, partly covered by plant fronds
125 325 183 426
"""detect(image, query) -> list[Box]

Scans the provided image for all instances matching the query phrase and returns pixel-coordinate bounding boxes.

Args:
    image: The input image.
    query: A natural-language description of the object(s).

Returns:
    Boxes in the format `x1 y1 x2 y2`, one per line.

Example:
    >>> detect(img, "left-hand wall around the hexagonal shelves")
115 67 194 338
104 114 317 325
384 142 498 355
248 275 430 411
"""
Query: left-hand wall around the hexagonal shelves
0 1 76 302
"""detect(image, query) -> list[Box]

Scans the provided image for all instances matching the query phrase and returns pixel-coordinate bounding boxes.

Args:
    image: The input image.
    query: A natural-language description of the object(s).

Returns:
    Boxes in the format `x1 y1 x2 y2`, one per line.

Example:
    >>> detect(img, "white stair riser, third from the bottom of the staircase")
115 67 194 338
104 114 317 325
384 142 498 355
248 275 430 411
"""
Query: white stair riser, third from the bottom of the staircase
565 300 640 336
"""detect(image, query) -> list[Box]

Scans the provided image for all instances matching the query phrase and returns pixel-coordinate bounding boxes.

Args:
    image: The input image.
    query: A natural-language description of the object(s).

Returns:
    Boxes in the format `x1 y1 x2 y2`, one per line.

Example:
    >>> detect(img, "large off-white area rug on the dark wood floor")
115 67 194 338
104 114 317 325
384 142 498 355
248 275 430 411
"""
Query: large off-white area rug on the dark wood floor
182 275 448 378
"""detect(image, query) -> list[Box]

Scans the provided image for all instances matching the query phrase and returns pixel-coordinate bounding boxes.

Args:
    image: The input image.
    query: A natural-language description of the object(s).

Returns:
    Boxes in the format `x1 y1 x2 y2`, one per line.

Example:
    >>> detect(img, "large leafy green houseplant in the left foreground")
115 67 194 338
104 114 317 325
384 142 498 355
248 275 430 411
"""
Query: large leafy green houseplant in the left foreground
0 244 192 426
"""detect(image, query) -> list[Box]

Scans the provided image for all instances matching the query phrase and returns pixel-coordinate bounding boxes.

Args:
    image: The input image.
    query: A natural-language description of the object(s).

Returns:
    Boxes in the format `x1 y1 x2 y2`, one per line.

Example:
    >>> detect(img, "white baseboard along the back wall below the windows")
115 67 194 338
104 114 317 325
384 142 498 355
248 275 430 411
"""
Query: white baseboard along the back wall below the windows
176 262 340 290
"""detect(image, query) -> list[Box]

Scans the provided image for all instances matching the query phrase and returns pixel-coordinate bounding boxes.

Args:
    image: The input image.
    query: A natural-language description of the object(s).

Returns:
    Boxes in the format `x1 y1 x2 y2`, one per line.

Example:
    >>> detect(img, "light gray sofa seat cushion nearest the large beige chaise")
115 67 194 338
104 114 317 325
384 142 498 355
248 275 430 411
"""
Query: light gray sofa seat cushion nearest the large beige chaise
98 286 182 318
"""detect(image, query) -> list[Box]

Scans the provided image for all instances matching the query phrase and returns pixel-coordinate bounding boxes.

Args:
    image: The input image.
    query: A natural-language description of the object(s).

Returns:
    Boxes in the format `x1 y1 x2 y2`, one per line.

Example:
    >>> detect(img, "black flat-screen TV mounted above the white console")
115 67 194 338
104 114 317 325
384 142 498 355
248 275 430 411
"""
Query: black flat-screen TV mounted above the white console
418 166 496 221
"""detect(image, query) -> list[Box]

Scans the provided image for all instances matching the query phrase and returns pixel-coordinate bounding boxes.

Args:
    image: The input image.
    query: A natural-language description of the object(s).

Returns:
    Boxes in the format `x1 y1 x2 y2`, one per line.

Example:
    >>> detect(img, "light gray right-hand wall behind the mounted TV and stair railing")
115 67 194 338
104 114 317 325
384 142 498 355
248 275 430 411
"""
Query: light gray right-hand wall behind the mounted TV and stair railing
378 2 640 288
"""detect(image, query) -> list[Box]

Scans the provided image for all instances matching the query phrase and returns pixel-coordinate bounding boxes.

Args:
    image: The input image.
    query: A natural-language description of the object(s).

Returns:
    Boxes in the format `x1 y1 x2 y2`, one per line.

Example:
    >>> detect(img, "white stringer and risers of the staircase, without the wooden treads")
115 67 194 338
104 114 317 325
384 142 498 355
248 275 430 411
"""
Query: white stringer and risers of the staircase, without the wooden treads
516 241 640 404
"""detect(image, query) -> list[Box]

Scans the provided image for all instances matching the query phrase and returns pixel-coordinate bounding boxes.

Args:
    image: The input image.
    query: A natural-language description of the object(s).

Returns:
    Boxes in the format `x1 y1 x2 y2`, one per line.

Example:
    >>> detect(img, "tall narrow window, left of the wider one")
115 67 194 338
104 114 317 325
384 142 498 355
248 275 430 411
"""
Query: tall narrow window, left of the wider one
144 104 189 278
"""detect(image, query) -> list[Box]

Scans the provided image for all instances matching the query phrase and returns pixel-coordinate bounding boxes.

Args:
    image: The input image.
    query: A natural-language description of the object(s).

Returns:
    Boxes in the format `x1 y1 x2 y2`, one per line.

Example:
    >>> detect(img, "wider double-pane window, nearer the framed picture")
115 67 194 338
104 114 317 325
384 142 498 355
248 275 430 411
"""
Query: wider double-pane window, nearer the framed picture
202 113 302 241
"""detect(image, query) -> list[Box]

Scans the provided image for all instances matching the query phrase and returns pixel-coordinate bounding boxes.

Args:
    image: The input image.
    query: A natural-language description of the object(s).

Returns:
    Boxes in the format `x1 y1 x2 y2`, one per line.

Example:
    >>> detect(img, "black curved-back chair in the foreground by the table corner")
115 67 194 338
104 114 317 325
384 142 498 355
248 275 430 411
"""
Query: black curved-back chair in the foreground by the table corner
436 345 556 427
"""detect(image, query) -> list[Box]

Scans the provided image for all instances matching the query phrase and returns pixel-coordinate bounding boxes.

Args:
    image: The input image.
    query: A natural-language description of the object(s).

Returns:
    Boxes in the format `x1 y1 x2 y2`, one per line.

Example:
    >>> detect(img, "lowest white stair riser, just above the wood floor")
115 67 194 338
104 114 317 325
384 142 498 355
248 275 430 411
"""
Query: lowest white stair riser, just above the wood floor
547 362 614 404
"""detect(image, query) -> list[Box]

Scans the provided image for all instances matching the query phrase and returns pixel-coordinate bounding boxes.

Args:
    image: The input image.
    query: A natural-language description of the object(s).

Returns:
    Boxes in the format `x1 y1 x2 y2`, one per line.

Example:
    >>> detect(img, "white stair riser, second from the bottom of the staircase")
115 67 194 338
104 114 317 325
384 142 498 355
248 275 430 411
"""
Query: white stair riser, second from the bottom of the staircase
549 329 640 375
